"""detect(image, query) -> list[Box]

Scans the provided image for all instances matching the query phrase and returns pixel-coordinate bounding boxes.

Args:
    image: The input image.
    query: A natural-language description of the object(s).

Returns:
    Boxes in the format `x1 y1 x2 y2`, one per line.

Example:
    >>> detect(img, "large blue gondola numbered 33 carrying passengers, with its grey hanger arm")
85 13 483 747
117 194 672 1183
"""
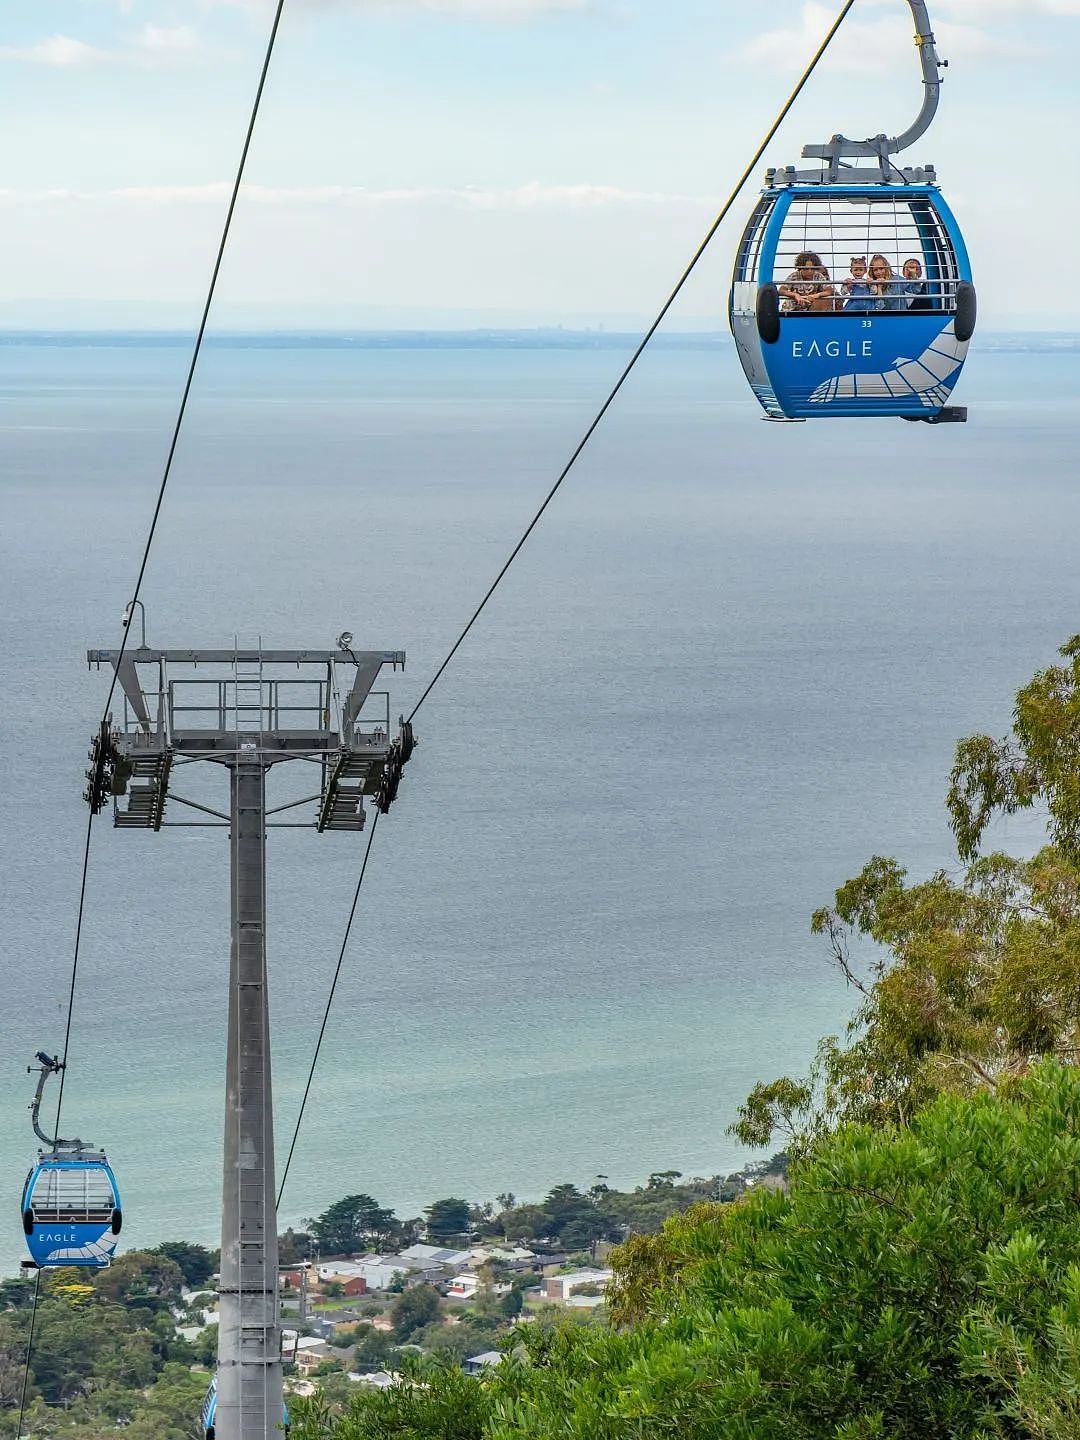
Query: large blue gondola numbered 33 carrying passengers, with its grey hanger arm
730 0 976 423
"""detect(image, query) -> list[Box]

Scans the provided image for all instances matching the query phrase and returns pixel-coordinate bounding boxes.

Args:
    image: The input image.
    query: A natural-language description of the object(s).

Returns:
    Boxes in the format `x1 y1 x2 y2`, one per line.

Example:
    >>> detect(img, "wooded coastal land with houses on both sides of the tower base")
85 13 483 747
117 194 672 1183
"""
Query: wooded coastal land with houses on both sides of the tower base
0 1153 788 1440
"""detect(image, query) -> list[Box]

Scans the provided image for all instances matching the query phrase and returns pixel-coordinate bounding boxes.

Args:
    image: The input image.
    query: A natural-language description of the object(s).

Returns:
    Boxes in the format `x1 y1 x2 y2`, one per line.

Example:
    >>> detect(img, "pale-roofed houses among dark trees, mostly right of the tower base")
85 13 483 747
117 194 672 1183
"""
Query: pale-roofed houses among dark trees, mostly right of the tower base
160 1155 786 1398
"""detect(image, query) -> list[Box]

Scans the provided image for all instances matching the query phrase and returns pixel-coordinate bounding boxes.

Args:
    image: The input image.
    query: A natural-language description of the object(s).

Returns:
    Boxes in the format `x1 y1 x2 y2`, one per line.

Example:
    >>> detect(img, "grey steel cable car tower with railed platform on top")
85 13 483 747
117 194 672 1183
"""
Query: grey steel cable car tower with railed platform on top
85 634 415 1440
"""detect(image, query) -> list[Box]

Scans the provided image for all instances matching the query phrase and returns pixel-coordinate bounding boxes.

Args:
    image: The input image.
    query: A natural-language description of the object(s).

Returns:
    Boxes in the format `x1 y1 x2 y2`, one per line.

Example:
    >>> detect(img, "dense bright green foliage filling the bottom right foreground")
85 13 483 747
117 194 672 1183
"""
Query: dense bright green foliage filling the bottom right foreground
298 1061 1080 1440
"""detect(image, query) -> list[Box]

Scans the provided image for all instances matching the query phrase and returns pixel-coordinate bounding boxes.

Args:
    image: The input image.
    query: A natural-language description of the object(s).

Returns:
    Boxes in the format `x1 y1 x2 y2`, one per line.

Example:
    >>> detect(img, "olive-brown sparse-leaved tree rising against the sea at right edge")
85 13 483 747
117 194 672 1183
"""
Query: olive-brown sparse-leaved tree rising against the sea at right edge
734 636 1080 1145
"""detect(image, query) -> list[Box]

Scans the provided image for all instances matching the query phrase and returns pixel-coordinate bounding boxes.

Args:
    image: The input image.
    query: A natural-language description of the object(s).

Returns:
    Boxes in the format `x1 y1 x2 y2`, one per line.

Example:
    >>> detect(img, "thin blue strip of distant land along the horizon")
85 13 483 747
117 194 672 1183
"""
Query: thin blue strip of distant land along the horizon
0 327 1080 354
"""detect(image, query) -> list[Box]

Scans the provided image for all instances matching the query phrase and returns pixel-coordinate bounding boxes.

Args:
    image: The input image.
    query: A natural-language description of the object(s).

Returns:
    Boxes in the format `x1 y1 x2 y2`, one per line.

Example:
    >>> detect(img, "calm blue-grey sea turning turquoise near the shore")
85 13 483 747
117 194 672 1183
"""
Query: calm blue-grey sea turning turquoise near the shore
0 343 1080 1264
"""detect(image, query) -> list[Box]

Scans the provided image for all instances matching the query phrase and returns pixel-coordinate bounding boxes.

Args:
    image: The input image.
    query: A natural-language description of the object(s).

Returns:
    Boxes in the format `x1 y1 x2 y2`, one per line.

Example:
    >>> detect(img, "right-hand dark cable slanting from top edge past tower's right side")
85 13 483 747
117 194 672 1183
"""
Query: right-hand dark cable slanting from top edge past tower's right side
278 0 855 1207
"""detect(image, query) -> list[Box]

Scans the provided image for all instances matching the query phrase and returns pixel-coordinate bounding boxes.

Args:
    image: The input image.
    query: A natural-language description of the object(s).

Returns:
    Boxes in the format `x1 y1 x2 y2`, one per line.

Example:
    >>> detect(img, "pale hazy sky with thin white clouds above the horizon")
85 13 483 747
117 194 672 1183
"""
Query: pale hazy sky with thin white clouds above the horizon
0 0 1080 328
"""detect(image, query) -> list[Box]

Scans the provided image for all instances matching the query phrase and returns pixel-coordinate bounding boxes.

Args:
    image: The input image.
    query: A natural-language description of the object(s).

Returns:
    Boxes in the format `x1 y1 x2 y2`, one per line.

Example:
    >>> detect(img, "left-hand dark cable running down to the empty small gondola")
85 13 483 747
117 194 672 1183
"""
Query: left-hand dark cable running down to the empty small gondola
14 0 285 1440
